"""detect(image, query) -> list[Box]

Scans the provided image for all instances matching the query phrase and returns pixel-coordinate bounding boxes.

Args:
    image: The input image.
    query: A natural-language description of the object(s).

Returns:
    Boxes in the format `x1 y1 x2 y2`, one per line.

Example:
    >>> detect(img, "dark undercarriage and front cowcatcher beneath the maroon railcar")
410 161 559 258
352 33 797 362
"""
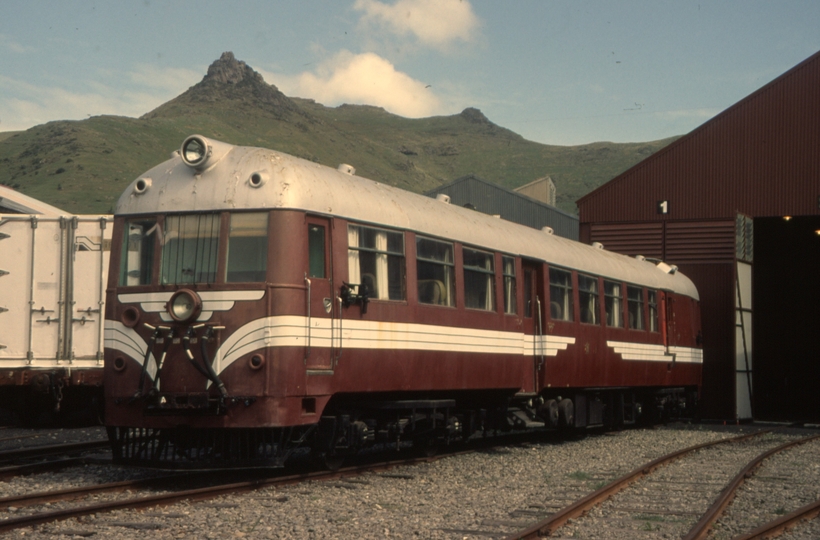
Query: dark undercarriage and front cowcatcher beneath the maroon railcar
108 388 696 469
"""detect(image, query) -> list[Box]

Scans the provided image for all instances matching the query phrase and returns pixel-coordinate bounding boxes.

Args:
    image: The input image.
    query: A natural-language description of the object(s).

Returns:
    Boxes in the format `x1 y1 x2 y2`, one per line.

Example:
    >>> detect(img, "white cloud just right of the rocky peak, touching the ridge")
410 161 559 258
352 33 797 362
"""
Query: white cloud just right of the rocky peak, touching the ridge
262 51 442 118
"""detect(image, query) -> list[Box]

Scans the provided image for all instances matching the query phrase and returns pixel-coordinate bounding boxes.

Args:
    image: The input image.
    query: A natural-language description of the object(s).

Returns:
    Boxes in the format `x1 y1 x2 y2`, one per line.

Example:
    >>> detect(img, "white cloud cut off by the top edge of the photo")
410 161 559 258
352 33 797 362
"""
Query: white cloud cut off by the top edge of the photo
354 0 479 48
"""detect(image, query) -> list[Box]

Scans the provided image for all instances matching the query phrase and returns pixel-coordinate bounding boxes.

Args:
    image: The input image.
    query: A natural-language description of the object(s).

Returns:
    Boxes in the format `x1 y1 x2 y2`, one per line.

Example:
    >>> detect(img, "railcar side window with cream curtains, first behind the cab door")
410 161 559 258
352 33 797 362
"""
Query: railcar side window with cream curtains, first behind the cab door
347 225 405 300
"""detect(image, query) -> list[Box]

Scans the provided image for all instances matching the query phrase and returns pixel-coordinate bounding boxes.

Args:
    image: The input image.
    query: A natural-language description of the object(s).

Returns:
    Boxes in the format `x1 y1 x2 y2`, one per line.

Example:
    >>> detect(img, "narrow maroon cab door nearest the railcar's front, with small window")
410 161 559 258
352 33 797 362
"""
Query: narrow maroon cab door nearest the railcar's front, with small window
305 216 340 373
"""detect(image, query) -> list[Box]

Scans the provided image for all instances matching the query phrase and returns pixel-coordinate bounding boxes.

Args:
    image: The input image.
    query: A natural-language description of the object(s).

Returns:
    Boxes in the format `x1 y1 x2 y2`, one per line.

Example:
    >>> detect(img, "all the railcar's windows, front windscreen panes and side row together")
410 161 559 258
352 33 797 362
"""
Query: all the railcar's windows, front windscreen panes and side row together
119 212 658 332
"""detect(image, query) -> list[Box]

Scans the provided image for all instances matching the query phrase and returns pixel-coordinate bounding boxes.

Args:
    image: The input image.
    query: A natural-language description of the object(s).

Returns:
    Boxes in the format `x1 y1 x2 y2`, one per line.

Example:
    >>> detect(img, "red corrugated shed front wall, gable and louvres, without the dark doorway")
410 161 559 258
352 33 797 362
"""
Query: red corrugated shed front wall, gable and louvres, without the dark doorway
578 53 820 419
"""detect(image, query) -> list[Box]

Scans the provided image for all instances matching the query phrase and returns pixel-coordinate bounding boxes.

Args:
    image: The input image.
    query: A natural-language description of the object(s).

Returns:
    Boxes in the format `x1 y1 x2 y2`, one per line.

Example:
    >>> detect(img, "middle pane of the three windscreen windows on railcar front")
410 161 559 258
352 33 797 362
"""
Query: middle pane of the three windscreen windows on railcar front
160 214 219 285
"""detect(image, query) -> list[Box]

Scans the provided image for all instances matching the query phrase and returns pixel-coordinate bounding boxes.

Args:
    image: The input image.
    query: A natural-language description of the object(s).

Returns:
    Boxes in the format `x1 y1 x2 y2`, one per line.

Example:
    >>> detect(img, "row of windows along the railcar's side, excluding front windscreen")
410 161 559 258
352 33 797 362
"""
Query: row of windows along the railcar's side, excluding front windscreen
326 221 658 332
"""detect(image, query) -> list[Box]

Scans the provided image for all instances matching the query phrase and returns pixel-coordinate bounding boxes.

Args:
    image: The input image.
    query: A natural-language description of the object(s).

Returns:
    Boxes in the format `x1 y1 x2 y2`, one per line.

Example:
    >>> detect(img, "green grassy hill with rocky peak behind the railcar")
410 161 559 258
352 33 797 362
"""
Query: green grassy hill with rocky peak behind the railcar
0 53 674 213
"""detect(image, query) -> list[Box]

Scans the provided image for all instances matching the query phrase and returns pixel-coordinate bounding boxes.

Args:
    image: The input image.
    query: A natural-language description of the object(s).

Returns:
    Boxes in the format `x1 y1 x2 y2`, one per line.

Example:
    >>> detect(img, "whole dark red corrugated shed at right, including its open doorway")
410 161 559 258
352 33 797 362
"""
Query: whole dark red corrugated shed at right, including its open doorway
578 53 820 421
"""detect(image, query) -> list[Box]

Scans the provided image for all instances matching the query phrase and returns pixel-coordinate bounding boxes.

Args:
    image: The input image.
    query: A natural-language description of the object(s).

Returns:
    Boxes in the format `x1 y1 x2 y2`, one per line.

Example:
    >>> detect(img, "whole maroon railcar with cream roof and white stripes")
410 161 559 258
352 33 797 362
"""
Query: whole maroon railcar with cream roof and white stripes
104 136 702 467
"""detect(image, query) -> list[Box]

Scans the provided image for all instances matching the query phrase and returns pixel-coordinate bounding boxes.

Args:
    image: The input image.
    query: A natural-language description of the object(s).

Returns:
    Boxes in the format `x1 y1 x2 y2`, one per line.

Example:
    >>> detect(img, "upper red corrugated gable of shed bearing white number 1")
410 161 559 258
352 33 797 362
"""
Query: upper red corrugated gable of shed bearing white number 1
578 48 820 224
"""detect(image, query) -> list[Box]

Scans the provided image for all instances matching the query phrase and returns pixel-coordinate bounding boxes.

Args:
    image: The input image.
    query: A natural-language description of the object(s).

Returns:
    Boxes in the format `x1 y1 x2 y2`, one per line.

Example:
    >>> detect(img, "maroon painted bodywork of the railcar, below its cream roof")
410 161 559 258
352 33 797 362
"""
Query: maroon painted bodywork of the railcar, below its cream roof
105 210 701 428
